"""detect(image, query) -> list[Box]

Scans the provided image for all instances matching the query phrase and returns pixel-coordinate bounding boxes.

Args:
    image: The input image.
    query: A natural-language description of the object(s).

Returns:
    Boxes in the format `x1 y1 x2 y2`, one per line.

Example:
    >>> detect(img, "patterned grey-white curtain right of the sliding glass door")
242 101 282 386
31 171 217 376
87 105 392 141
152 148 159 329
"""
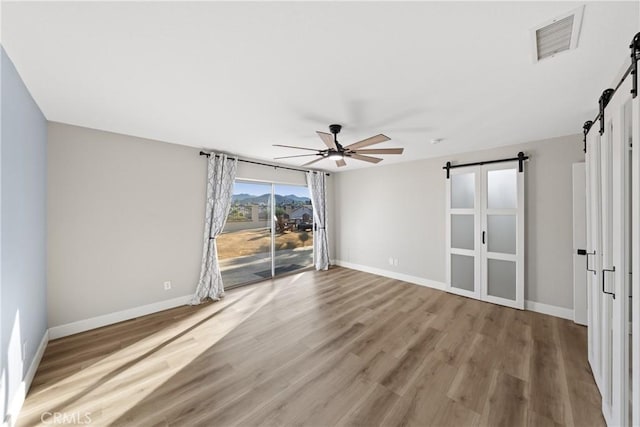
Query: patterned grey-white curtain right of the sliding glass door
307 172 329 270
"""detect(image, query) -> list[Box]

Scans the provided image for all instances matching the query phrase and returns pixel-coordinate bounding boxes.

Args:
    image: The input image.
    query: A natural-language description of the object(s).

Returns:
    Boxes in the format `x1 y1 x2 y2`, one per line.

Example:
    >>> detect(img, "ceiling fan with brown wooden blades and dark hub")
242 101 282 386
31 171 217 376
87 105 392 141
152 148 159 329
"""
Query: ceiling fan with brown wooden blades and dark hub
273 125 404 167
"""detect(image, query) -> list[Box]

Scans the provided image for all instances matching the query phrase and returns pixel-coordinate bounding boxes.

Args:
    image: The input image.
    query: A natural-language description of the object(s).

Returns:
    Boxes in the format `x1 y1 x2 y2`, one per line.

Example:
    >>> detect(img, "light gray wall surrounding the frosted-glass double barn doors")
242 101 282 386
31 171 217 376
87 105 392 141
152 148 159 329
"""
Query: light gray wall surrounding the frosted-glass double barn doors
335 135 584 308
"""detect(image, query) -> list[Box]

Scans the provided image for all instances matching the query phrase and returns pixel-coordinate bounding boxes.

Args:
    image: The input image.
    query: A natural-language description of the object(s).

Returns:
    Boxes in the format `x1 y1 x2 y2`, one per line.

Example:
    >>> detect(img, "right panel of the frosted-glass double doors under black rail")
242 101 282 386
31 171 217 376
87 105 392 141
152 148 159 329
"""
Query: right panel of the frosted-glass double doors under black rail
481 161 524 309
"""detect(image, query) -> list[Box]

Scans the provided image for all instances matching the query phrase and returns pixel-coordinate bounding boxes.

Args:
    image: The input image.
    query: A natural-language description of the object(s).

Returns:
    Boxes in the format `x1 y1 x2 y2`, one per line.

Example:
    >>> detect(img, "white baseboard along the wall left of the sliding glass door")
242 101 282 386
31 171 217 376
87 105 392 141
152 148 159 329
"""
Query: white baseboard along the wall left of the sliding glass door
49 295 192 340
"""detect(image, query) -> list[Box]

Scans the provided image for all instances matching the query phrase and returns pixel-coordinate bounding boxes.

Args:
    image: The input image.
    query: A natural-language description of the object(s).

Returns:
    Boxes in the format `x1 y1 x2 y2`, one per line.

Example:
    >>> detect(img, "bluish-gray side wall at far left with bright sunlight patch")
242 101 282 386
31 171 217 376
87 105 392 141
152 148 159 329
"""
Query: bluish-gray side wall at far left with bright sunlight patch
0 49 47 419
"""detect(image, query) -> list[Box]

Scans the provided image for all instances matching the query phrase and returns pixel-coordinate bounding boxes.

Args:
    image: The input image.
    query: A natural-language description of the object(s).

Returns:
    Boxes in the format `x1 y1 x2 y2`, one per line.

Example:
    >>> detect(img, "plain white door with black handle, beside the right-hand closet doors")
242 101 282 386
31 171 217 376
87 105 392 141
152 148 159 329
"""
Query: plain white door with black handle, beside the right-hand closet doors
572 163 587 325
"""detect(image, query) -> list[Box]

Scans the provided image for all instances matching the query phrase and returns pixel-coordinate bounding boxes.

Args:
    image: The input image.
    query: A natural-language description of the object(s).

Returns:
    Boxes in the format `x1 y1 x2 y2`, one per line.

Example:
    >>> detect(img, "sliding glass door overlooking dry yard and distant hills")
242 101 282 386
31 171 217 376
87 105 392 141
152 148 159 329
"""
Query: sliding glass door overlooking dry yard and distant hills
217 180 313 289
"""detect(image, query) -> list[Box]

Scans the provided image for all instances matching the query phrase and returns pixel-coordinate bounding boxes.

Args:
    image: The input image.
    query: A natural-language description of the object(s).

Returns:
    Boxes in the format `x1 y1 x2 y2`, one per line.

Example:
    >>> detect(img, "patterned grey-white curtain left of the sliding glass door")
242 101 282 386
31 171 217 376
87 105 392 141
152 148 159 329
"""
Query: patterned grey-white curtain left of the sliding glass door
191 153 238 304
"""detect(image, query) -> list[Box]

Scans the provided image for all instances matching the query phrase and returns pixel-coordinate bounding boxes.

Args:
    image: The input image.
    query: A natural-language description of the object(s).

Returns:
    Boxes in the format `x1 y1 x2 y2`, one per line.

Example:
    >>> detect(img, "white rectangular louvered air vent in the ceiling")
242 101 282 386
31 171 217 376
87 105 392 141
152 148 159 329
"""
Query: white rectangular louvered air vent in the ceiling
532 6 584 62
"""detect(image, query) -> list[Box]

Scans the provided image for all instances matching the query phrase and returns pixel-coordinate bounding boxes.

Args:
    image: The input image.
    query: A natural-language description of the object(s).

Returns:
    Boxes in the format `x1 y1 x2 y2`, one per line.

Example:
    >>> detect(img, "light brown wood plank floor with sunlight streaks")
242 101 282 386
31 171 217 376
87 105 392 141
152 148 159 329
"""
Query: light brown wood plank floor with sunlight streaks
18 267 604 426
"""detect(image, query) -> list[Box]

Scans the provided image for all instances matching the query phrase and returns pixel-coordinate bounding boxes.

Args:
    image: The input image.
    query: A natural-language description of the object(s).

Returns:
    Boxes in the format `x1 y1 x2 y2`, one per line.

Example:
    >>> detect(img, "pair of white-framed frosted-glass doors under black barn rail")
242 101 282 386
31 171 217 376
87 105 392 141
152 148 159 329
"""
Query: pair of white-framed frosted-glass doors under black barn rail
446 161 524 309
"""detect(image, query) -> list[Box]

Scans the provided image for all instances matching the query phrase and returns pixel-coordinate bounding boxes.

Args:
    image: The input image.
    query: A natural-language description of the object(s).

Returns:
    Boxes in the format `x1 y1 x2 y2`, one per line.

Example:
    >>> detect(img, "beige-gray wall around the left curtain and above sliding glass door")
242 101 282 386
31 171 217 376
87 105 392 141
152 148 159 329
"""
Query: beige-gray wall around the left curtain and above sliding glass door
47 123 332 327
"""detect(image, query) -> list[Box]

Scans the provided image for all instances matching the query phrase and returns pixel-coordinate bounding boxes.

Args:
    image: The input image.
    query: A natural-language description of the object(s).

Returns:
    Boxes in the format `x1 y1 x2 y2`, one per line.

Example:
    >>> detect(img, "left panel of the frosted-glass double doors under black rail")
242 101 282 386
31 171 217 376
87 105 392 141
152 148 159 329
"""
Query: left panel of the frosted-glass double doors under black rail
446 167 481 299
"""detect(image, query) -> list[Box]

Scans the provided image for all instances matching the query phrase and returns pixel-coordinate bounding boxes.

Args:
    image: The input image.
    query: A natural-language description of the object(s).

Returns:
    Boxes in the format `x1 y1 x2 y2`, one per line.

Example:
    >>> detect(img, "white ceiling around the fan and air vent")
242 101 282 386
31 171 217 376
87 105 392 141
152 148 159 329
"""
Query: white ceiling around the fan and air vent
2 1 640 170
